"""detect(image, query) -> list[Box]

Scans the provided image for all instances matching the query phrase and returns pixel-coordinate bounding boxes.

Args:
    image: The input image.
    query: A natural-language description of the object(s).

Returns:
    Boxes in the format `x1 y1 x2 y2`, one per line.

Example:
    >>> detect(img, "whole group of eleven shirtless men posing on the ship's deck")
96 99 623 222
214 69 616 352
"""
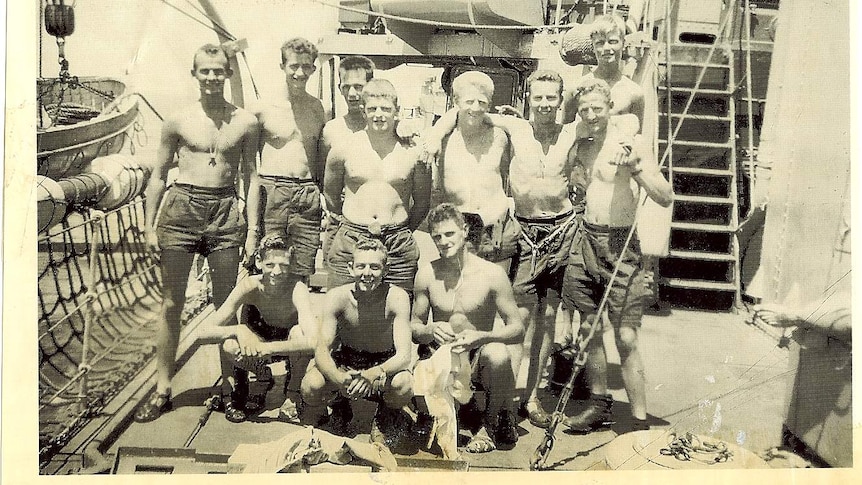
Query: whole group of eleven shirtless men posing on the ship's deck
135 16 673 452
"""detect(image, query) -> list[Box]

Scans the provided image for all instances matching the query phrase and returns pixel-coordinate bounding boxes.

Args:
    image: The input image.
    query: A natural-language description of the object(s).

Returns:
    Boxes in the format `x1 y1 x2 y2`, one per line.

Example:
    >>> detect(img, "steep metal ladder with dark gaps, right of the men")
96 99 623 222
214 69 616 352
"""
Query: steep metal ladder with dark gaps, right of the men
657 43 740 309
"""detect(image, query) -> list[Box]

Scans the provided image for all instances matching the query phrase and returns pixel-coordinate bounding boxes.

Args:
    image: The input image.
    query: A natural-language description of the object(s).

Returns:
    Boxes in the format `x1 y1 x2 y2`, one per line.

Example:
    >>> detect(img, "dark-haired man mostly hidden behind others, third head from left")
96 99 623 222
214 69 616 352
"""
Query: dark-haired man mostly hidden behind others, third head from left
320 56 374 257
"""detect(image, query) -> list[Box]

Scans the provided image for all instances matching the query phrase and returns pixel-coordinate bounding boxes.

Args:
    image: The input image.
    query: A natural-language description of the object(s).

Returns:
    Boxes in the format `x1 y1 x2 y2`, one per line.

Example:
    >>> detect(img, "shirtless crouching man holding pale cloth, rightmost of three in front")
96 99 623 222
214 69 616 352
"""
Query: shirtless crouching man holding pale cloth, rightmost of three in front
411 203 524 453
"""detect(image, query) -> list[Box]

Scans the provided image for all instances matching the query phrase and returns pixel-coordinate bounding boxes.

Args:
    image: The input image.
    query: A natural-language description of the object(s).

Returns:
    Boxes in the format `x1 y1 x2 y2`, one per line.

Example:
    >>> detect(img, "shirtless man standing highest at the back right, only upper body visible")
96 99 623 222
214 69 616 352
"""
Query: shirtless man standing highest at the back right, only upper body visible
563 14 644 133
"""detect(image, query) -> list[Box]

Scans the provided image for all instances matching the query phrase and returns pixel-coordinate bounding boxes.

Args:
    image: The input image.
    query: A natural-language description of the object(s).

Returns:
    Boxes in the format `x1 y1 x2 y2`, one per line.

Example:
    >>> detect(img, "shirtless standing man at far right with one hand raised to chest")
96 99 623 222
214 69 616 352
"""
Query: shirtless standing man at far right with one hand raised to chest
563 79 673 432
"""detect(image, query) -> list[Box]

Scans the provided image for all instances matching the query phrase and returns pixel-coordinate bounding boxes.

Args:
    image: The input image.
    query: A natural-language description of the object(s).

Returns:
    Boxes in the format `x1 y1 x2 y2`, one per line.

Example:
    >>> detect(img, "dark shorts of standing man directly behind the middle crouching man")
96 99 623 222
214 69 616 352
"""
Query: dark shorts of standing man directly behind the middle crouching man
326 220 419 291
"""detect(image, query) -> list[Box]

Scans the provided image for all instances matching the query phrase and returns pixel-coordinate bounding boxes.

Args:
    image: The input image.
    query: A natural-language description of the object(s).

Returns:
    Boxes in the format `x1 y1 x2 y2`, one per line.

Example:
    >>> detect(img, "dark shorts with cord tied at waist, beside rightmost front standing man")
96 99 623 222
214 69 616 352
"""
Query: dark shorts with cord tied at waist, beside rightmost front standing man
513 211 580 295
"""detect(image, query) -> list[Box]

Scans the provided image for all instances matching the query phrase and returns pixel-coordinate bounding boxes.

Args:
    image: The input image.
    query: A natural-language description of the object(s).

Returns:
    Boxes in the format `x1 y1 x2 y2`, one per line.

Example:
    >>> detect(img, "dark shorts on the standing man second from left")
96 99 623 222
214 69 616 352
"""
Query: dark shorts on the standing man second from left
258 175 323 276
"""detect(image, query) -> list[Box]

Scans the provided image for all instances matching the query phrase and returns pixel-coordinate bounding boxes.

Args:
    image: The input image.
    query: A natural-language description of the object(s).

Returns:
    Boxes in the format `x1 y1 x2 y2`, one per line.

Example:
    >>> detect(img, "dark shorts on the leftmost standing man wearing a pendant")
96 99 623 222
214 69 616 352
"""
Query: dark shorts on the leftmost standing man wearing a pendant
156 183 247 255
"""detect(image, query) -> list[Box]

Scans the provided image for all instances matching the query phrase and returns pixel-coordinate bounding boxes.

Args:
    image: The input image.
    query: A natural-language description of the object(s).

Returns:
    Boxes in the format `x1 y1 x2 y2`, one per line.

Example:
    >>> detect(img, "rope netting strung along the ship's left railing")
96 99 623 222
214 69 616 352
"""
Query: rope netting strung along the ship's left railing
37 197 210 465
